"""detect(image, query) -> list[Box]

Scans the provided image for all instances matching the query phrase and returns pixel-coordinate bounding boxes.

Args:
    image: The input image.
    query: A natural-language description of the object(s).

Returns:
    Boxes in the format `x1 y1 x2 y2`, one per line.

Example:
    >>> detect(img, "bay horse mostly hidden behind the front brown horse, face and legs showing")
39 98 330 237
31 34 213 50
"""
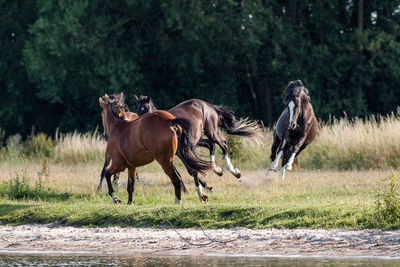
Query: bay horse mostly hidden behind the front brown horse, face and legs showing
97 93 139 192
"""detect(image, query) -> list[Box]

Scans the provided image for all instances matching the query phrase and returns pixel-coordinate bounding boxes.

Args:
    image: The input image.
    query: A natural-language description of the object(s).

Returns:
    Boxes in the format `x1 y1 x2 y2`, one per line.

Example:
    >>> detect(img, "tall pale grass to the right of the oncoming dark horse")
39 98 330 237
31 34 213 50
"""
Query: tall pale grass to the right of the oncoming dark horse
301 112 400 170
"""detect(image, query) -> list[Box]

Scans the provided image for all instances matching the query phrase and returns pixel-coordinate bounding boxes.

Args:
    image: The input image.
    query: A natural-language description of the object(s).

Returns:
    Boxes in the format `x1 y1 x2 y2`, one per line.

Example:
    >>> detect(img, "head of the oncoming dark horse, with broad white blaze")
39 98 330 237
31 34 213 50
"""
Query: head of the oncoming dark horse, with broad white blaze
285 80 310 129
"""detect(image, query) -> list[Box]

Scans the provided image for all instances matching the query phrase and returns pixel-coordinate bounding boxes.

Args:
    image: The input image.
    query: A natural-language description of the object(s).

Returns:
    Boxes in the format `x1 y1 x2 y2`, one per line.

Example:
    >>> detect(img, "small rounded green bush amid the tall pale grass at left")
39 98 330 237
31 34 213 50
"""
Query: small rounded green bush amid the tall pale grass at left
24 133 54 157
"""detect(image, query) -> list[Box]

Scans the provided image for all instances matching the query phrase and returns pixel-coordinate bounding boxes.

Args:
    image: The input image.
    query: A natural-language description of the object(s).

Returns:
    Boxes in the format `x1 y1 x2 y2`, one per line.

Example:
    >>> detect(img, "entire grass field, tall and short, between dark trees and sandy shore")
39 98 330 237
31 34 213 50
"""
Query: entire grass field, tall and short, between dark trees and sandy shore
0 114 400 229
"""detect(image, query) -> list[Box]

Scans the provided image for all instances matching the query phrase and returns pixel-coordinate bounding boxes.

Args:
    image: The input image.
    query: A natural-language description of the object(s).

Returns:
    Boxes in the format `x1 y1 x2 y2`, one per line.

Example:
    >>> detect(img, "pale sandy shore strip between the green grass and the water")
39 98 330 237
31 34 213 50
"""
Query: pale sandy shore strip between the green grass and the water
0 225 400 257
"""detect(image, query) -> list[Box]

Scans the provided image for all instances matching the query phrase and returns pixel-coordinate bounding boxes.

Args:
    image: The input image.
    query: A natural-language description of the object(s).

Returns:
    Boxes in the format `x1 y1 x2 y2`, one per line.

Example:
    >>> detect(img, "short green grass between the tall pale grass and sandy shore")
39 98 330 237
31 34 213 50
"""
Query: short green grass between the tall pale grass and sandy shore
0 160 400 229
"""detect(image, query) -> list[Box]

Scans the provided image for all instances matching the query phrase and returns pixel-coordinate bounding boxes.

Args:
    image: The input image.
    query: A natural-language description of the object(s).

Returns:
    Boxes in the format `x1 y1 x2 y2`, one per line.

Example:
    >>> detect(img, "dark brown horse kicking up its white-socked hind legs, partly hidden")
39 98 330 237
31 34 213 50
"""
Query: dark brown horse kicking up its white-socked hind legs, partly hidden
134 95 261 179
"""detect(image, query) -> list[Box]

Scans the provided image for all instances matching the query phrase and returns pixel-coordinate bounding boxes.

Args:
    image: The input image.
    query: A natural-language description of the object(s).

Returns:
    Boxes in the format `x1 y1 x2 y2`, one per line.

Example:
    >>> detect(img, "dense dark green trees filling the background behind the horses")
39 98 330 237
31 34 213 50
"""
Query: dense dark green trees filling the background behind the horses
0 0 400 136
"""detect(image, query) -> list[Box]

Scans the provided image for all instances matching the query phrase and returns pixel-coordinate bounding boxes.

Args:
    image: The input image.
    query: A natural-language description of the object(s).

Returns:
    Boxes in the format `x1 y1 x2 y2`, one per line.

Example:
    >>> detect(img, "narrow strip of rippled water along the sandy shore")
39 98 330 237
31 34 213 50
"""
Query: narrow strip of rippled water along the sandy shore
0 253 400 267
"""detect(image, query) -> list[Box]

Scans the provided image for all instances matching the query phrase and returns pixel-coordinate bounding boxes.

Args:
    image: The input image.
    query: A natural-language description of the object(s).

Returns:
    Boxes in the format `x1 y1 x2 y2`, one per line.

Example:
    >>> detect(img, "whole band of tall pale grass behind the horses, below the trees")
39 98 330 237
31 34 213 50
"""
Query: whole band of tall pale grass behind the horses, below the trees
0 110 400 170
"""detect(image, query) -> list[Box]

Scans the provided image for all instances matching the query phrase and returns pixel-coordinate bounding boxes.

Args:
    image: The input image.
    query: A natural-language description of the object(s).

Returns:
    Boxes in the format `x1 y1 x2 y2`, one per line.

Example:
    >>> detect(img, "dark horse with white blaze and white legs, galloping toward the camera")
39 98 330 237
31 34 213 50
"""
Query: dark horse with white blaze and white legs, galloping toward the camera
267 80 318 179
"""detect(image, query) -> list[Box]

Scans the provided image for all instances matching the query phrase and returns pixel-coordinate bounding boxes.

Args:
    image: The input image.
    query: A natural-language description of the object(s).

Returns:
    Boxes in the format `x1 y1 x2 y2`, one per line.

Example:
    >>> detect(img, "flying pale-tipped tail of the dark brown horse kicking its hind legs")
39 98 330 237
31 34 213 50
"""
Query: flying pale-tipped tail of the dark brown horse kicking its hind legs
214 105 262 142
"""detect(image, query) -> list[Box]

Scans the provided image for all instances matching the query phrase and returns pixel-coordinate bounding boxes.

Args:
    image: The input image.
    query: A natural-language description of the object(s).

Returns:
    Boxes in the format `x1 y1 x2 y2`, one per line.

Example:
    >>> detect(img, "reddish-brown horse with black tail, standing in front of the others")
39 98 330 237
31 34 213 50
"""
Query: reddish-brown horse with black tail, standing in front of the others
99 95 212 205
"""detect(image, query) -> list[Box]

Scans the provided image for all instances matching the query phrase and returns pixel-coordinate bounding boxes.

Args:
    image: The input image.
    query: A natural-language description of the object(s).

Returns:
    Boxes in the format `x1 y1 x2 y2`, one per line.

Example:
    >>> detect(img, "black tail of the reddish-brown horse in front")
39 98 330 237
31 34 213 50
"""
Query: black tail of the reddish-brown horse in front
172 118 212 175
